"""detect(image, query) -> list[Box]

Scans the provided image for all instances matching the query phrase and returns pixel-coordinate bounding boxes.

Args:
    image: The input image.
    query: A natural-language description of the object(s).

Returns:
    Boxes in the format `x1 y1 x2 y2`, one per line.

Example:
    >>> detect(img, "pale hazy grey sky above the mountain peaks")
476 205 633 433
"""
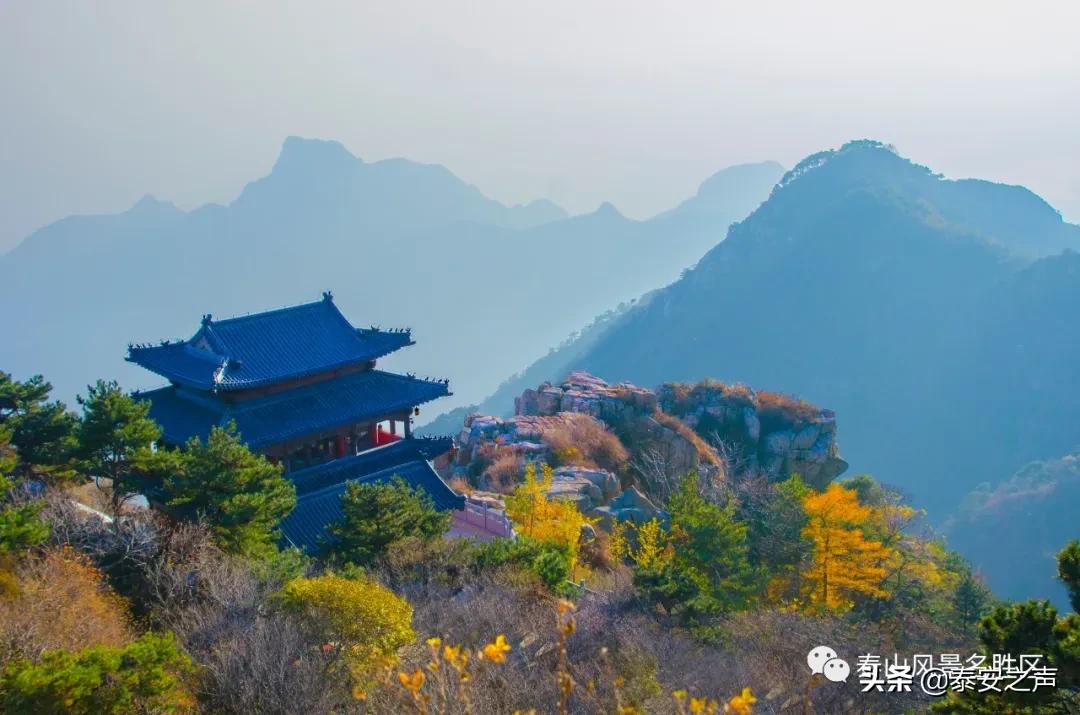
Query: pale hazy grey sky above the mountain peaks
0 0 1080 249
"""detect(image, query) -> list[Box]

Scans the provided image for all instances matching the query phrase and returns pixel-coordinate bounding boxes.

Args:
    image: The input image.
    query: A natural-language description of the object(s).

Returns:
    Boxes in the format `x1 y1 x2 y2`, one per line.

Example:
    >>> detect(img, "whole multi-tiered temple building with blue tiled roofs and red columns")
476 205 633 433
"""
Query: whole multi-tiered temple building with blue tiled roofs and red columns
127 293 464 552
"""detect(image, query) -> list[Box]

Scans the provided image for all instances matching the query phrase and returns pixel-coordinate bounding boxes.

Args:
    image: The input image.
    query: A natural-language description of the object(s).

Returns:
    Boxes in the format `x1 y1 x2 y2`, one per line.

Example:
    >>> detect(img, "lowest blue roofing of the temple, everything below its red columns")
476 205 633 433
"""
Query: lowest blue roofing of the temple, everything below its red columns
280 440 464 553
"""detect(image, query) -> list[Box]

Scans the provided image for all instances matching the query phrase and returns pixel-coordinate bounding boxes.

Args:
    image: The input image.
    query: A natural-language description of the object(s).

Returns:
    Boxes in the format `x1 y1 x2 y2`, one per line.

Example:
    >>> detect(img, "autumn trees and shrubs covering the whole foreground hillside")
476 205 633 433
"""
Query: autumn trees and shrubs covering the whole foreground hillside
10 374 1080 715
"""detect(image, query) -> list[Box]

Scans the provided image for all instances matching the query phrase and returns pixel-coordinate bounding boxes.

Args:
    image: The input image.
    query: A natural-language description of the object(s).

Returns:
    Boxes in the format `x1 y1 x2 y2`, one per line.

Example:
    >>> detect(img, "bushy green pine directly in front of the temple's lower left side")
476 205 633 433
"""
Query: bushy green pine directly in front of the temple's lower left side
165 423 296 556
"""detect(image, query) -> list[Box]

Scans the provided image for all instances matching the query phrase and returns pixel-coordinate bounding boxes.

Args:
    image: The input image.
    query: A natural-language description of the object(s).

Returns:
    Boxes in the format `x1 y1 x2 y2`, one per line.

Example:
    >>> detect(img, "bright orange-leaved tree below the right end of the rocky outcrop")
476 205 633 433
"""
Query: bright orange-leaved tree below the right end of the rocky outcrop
802 484 892 608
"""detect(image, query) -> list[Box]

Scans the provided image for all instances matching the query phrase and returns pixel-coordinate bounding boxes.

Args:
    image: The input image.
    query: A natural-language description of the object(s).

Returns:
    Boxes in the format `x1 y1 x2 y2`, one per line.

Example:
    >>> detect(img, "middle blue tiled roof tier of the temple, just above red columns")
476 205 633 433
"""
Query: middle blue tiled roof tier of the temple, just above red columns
135 369 450 449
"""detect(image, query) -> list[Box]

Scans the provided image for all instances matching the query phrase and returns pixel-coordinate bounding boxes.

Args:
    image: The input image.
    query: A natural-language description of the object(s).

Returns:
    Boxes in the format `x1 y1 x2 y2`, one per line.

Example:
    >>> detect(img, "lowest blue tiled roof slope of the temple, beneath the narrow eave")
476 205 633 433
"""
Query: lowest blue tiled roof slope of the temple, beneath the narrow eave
281 453 464 553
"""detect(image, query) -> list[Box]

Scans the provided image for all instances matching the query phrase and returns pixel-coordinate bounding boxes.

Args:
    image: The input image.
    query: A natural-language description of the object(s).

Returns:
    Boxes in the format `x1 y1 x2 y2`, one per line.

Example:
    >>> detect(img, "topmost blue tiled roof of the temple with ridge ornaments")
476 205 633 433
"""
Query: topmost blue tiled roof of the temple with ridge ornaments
127 293 413 391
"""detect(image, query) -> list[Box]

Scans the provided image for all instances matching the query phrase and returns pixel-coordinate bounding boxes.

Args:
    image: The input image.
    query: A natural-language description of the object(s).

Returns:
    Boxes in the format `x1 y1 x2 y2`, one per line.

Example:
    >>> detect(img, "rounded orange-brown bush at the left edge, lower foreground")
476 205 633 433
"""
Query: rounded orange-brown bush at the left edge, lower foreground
0 547 132 662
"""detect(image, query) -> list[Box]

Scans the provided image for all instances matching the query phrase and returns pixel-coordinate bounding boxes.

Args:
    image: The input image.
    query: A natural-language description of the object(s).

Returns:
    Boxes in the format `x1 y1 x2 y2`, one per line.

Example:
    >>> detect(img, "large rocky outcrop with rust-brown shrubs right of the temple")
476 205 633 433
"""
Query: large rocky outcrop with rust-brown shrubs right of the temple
454 372 847 524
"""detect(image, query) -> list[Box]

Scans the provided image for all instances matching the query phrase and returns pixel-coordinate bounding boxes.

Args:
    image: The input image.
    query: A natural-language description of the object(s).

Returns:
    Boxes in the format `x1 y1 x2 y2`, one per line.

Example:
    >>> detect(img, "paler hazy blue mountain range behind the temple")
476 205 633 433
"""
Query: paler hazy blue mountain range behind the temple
0 137 783 406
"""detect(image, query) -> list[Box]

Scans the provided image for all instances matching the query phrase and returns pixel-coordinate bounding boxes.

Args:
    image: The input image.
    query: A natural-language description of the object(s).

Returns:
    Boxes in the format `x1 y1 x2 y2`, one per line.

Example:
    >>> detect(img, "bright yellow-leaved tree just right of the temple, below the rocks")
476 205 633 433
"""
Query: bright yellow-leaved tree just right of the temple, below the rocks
507 463 591 567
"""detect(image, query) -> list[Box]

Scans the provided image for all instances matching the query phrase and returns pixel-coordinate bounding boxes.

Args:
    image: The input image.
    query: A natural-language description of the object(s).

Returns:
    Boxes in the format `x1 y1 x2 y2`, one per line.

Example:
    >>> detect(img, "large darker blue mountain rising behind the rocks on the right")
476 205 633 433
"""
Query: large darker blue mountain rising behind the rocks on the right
432 141 1080 521
